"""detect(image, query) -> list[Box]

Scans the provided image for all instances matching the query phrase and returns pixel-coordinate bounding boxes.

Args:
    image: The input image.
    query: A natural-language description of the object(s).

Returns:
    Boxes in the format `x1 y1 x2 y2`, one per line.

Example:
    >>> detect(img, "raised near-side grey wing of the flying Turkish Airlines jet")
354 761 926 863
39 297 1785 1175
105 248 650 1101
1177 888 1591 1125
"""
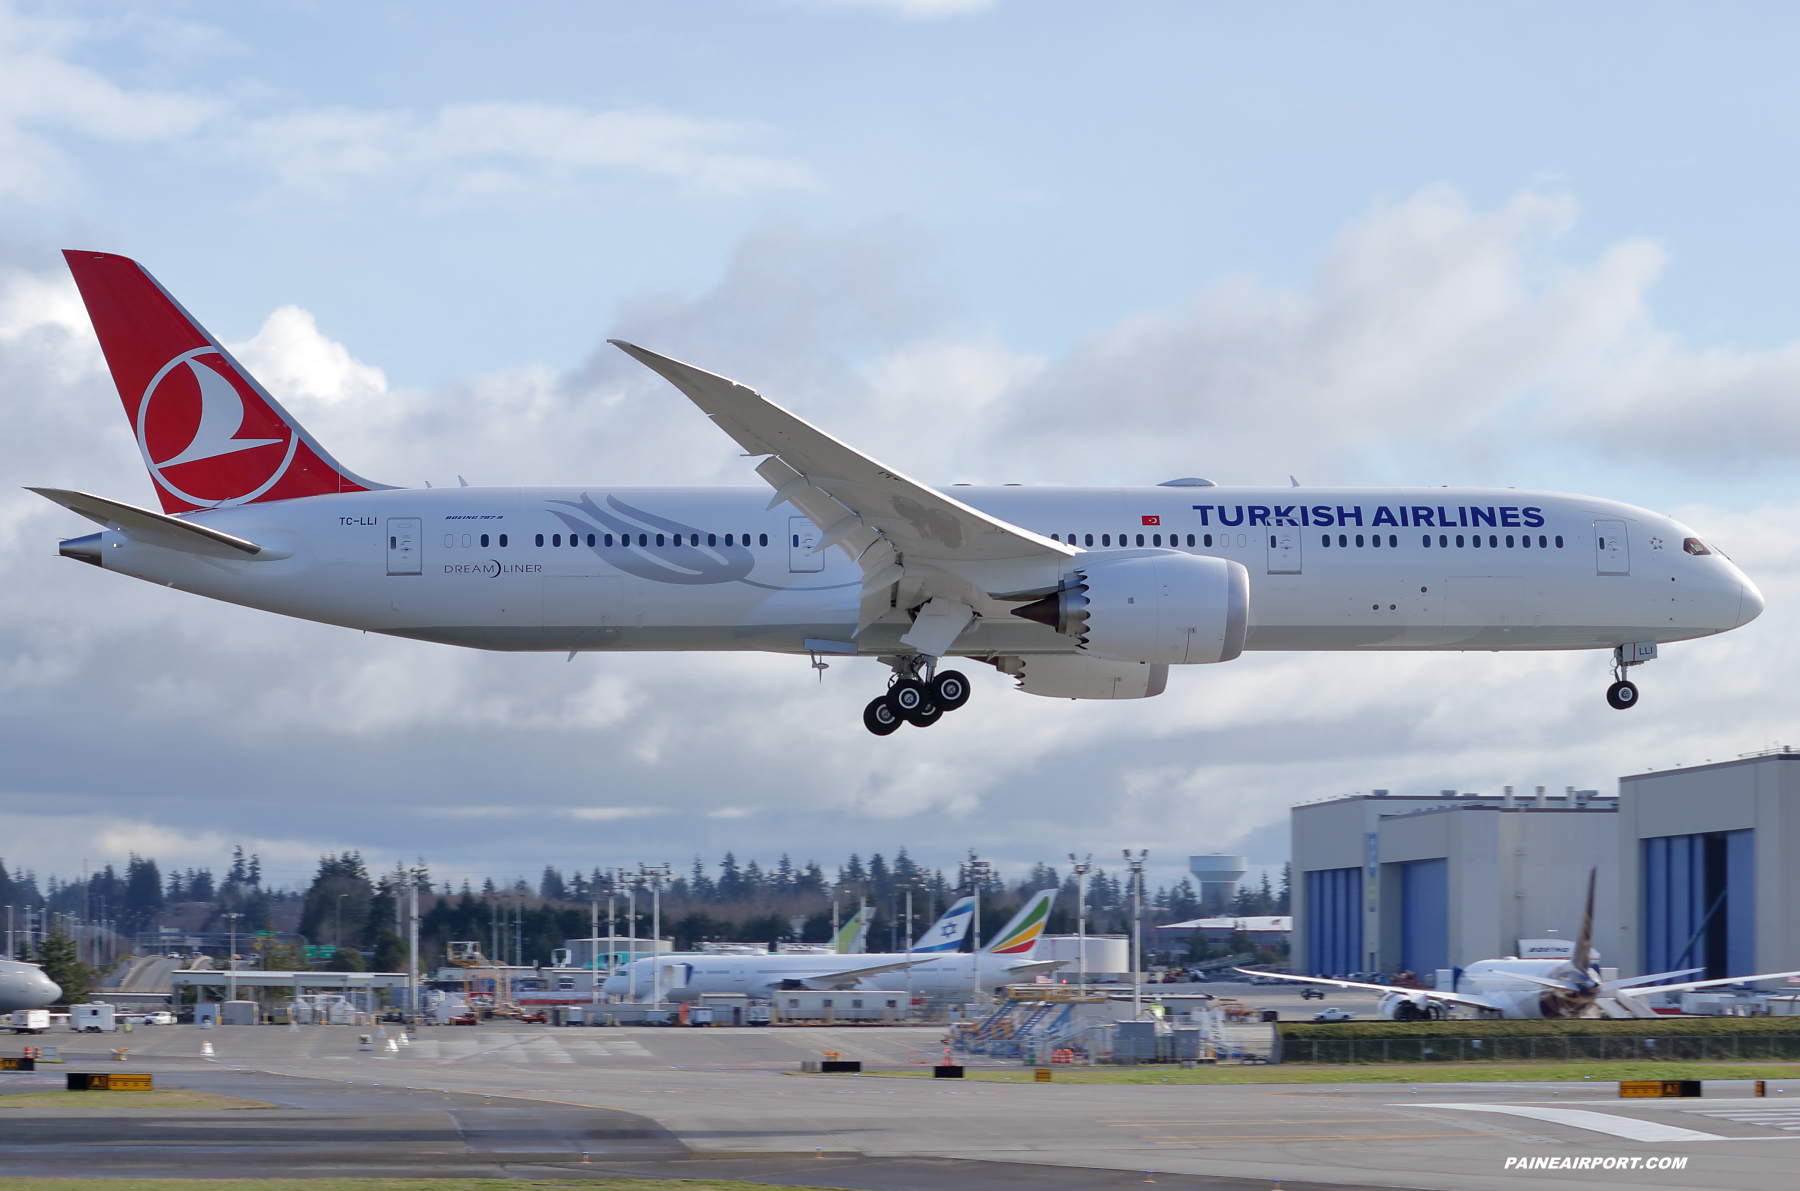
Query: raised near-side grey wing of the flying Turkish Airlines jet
608 340 1080 640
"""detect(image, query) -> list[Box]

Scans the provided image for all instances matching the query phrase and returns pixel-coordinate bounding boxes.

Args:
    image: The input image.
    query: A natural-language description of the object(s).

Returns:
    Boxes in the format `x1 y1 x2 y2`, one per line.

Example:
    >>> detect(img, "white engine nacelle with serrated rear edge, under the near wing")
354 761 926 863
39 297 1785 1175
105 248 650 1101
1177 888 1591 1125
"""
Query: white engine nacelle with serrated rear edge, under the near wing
1013 551 1249 666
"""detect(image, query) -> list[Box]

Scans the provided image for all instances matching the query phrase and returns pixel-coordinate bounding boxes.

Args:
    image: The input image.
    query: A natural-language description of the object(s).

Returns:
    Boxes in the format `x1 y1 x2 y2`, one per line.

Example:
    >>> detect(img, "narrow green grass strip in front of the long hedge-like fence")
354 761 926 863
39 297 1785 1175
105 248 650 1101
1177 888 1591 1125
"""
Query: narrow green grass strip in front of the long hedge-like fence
853 1063 1800 1099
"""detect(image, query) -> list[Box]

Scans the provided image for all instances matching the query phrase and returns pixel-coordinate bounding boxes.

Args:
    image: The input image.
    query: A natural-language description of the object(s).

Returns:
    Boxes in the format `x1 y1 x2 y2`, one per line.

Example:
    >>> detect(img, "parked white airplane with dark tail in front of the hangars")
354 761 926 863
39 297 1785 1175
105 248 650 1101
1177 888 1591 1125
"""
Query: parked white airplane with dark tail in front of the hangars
1238 869 1800 1022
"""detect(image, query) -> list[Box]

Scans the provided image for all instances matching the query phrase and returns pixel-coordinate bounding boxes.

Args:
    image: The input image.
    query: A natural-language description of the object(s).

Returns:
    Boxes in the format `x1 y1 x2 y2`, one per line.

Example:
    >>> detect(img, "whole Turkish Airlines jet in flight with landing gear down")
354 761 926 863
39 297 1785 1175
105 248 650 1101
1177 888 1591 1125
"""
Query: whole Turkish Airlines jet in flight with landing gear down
32 252 1762 736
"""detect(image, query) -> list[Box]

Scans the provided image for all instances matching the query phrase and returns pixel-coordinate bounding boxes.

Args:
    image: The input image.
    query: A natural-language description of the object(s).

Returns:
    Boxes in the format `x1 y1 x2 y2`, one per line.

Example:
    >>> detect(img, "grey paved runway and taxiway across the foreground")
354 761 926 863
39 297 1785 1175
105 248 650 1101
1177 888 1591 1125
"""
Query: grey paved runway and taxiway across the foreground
0 1025 1800 1191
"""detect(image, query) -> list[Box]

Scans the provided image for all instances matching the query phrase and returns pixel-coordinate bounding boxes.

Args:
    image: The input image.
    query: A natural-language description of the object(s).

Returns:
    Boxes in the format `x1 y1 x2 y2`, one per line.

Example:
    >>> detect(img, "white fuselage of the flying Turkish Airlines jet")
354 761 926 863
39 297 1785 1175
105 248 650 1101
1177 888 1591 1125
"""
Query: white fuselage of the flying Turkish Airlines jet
81 486 1762 657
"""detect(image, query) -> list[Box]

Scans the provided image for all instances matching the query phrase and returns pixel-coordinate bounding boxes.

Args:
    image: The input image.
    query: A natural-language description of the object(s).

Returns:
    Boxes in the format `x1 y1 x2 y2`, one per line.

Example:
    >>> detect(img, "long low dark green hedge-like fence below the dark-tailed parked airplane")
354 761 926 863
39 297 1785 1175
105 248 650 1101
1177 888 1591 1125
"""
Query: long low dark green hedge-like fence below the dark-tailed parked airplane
1282 1033 1800 1063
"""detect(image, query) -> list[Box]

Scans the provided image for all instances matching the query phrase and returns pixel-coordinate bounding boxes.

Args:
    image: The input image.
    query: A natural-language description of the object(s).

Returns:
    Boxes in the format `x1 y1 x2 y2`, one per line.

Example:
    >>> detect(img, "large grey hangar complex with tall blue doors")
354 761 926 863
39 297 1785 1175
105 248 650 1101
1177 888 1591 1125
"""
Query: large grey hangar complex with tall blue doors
1291 748 1800 982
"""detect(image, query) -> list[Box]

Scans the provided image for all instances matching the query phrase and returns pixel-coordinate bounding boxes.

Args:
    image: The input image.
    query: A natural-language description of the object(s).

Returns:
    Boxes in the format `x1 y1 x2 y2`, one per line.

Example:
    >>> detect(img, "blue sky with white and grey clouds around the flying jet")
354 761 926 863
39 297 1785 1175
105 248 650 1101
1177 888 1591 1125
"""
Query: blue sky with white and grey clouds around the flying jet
0 0 1800 895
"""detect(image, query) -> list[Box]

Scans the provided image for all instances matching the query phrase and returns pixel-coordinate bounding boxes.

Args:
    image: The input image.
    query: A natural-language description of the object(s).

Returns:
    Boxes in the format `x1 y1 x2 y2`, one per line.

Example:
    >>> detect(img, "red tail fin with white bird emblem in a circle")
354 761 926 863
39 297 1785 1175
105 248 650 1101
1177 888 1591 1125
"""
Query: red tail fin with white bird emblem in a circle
63 252 389 513
